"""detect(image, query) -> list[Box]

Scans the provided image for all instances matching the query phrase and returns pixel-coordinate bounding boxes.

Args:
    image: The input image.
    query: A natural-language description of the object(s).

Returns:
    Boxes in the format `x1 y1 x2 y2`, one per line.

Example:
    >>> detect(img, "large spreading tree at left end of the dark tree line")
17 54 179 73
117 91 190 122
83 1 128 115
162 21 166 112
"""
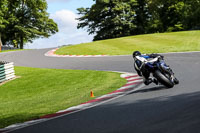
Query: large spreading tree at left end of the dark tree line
77 0 137 40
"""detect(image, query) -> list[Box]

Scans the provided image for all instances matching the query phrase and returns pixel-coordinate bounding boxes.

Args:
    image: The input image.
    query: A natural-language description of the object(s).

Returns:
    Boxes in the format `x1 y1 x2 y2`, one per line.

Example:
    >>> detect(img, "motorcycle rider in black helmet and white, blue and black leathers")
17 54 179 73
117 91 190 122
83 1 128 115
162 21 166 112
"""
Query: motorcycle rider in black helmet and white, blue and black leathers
133 51 164 85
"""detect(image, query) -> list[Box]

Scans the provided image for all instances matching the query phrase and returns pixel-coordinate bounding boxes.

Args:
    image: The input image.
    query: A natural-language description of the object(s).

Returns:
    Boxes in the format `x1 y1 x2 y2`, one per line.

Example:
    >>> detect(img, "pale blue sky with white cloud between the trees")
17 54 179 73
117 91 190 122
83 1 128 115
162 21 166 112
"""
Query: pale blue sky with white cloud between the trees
25 0 94 49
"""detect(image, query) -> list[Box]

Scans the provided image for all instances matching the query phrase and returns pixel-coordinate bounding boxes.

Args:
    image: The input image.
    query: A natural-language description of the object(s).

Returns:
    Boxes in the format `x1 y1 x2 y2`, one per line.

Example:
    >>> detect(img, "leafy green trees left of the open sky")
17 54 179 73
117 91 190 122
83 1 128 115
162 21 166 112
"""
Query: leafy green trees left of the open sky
0 0 58 49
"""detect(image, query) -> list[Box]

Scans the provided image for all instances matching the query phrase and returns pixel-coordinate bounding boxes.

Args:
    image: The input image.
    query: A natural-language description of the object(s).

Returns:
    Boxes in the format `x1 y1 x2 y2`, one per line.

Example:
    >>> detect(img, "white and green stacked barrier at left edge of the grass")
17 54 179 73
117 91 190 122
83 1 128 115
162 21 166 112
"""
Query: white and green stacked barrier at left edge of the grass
0 61 15 83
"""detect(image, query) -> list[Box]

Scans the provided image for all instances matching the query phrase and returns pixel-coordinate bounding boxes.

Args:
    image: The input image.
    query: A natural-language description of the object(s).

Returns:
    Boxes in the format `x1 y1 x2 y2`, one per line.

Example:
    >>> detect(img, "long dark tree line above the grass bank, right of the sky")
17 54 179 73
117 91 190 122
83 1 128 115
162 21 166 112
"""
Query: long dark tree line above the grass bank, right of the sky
77 0 200 40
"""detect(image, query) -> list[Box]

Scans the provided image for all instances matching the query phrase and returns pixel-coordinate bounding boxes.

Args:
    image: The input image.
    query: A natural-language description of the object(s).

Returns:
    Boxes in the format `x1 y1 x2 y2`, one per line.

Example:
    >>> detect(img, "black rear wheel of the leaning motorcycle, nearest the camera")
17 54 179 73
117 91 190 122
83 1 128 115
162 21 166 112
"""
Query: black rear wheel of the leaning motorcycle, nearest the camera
154 70 174 88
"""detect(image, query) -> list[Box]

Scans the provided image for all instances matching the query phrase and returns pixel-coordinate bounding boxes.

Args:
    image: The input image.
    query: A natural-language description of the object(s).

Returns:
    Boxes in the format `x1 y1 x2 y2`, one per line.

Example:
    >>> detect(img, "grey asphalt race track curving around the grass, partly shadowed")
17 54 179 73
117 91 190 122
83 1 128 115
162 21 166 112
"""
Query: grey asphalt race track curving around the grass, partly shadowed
0 49 200 133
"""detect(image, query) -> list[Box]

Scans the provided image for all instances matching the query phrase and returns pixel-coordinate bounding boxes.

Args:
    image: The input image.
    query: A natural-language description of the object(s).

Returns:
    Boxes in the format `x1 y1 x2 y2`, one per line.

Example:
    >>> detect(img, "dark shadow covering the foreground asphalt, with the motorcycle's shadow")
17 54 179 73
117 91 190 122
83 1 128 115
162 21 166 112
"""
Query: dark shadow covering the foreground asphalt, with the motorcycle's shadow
9 86 200 133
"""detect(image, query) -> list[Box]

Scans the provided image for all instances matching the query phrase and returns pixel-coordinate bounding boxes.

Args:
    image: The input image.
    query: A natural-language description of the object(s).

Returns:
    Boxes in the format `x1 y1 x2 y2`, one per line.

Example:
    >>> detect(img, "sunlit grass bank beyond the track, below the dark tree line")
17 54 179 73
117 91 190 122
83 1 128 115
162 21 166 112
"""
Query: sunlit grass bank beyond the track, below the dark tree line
56 31 200 55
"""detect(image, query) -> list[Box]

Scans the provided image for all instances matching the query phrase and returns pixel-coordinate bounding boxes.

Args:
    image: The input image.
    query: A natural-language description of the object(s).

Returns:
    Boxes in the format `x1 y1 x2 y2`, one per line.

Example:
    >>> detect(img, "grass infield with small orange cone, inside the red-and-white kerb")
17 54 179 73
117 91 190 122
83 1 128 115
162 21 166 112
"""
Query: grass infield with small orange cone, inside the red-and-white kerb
0 67 126 128
